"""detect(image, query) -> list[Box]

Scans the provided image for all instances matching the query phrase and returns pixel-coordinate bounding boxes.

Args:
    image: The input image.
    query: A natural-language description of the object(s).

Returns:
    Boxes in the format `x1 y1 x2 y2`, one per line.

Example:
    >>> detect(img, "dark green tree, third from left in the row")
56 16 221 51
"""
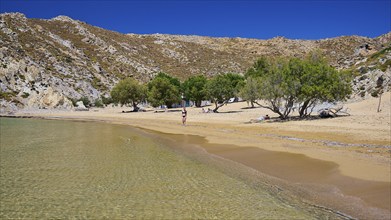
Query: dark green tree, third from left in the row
183 75 207 107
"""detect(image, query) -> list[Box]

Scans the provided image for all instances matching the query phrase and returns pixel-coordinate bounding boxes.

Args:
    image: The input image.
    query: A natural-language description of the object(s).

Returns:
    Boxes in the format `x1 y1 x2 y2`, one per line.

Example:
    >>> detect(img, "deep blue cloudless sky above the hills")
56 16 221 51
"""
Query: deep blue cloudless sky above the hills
0 0 391 39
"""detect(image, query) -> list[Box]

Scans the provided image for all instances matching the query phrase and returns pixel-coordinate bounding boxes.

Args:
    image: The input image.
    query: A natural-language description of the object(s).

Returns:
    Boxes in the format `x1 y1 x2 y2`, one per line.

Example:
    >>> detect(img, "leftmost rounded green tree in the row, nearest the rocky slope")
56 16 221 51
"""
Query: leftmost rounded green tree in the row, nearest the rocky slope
110 78 146 111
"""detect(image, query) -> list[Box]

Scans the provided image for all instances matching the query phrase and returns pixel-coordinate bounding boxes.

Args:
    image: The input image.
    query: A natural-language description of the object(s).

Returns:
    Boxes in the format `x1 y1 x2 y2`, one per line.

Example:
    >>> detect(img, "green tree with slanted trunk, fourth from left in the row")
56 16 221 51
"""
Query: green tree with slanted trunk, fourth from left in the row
206 73 244 112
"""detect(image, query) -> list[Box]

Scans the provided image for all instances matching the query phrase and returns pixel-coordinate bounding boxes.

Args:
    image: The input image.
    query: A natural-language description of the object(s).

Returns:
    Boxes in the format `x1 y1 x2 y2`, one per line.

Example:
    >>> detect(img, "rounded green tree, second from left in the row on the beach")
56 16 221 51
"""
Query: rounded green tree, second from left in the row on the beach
148 77 180 107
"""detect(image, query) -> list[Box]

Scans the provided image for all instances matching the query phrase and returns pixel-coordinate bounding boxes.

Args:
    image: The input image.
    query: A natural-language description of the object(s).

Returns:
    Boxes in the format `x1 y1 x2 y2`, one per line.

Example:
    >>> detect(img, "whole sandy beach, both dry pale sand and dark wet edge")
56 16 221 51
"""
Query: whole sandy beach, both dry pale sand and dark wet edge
6 92 391 219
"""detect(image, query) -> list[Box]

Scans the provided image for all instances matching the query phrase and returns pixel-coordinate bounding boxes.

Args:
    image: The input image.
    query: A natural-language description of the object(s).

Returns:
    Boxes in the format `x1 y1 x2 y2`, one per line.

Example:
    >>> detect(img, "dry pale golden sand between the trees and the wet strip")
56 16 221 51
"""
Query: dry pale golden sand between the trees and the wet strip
19 93 391 181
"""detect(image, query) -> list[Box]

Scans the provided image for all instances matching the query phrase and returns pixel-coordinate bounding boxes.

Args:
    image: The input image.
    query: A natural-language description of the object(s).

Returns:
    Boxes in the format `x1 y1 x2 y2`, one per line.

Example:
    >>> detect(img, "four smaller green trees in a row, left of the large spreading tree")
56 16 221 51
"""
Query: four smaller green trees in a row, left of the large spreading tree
111 73 244 112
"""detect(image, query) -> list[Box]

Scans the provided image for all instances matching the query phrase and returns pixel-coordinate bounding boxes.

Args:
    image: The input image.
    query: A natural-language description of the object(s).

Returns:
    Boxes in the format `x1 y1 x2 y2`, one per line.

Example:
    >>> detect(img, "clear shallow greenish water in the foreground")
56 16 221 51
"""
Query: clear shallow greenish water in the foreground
0 118 330 219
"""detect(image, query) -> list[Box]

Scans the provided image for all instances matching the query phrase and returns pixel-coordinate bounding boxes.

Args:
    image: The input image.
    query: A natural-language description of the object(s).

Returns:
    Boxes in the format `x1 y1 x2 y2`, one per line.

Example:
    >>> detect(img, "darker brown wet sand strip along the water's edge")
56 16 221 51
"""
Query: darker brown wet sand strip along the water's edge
153 132 391 219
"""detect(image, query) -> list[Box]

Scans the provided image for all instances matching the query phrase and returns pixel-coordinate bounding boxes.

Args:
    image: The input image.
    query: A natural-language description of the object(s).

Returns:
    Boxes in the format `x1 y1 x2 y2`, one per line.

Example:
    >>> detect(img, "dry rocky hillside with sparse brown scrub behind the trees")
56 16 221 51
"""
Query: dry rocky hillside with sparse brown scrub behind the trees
0 13 391 112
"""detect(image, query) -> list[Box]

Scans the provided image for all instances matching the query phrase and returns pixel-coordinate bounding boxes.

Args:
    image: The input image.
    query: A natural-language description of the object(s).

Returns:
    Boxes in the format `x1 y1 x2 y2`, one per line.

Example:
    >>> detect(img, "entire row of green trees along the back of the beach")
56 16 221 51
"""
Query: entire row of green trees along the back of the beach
111 53 351 119
